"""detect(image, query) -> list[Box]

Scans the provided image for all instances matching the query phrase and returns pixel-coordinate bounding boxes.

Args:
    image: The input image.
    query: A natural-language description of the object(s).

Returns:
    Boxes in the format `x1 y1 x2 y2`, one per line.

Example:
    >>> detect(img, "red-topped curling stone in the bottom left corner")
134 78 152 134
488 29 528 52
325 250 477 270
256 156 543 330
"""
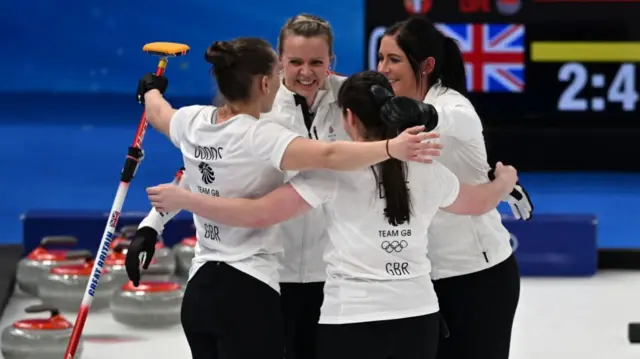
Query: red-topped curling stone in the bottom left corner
2 305 83 359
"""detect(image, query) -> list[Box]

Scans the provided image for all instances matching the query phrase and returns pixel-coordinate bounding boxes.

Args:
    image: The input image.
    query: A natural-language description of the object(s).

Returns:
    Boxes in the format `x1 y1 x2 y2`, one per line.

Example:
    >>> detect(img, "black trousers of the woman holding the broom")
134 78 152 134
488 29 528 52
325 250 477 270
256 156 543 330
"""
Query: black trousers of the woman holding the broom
181 262 284 359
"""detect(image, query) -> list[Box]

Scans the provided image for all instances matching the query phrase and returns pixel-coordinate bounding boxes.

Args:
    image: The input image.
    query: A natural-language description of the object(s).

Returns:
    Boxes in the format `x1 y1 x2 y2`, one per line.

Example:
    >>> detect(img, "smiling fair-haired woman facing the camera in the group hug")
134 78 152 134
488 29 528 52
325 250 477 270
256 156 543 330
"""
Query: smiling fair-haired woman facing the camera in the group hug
126 14 356 359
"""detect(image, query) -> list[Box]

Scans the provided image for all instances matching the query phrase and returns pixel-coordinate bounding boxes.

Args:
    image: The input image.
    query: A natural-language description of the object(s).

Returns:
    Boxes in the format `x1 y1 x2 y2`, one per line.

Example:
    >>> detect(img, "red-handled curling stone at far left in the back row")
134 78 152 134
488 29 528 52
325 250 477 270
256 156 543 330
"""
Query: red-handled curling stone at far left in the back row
16 236 82 295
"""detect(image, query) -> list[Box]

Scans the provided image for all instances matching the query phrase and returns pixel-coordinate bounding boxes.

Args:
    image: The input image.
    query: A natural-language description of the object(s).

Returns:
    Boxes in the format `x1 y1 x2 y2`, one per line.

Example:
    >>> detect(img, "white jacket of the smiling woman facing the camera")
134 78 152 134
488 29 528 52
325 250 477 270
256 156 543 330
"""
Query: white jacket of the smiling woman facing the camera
268 75 350 283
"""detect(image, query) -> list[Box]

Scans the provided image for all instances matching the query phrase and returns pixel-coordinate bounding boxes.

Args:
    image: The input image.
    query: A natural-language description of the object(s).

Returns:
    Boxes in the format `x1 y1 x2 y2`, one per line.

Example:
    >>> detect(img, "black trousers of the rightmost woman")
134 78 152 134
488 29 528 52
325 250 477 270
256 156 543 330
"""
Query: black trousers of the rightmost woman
433 254 520 359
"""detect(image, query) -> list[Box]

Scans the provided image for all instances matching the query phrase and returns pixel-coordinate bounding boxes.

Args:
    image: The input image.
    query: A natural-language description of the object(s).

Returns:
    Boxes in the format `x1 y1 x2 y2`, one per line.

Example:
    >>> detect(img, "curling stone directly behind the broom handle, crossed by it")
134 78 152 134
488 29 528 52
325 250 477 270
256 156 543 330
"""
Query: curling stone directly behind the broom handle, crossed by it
38 251 117 312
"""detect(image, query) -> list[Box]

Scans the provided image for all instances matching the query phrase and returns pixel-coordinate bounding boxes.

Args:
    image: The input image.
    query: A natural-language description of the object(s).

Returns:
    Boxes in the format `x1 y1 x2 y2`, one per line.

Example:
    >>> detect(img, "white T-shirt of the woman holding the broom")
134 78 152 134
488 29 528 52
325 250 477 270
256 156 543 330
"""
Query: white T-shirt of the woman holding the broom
169 106 298 292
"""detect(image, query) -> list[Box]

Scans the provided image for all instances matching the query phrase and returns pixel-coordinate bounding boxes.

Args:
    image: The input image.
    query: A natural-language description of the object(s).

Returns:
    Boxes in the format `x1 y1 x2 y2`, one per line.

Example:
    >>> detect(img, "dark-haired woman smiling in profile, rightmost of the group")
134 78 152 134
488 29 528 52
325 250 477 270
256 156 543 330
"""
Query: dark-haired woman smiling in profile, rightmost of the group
378 17 533 359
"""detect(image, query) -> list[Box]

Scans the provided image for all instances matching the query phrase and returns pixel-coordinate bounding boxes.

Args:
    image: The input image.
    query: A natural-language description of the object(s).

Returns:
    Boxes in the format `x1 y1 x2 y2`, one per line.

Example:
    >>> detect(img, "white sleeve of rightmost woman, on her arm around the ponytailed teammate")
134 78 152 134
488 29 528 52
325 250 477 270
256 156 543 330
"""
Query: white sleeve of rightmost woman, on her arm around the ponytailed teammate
433 105 482 141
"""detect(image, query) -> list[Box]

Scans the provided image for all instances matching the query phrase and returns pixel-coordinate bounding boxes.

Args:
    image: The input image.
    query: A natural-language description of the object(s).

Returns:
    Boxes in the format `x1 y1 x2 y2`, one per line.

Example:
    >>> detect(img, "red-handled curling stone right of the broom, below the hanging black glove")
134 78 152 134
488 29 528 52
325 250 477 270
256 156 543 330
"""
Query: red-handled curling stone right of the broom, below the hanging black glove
110 267 184 328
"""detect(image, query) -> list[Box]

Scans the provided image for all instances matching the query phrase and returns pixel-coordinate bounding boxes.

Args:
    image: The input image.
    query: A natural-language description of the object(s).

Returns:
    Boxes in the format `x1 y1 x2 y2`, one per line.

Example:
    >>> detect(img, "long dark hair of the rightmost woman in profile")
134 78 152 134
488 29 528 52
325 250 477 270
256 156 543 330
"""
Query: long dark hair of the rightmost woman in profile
385 16 467 95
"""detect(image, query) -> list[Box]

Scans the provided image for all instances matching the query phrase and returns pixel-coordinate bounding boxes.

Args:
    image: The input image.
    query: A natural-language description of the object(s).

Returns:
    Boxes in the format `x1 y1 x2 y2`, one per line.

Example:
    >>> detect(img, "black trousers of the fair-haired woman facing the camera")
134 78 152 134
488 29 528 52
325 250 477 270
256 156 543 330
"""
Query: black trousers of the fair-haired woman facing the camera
280 282 324 359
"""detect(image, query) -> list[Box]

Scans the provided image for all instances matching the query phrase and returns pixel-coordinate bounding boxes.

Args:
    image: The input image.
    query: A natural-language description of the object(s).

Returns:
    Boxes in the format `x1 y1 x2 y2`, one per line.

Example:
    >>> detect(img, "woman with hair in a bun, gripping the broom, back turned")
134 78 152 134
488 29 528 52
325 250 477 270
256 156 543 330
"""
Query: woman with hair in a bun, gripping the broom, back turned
133 38 432 359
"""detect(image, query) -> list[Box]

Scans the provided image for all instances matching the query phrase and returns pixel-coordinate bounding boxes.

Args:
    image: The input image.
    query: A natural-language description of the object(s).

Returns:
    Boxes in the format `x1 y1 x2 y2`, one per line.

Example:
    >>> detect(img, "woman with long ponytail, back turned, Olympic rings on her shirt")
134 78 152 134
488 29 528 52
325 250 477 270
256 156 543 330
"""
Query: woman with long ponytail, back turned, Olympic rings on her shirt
147 71 517 359
